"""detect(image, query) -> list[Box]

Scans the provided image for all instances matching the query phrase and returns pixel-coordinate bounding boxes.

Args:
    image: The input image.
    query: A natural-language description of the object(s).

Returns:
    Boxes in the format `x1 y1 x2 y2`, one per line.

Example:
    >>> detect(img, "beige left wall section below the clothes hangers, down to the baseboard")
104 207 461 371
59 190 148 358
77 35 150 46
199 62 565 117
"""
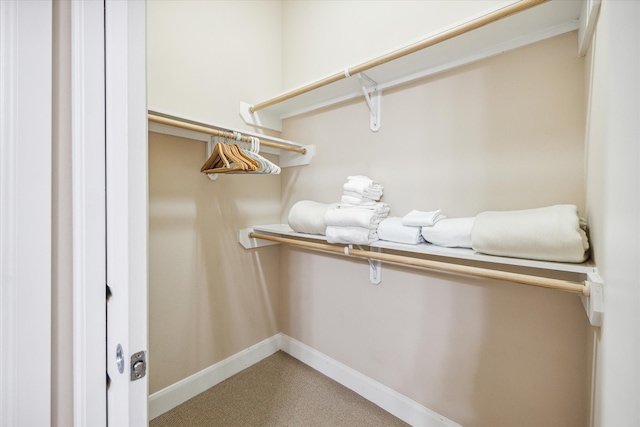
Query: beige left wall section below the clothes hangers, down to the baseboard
149 133 280 393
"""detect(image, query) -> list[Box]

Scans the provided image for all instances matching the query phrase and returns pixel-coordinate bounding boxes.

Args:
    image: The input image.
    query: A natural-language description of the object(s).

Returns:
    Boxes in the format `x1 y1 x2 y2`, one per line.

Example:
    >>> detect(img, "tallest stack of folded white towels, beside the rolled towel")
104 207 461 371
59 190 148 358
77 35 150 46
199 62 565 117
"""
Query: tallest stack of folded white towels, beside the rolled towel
324 175 389 245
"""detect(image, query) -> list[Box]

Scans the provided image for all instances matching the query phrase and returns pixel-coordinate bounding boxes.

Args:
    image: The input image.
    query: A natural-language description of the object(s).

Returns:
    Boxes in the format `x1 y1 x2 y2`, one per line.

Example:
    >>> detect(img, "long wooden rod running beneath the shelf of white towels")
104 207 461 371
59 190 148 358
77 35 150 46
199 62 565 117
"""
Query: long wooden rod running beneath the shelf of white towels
249 233 590 297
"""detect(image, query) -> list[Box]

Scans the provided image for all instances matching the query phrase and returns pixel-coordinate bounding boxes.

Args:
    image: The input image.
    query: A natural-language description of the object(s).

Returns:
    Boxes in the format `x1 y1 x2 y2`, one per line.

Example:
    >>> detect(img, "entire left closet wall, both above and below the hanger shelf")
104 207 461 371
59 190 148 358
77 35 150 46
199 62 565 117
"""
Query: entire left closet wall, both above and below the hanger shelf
147 1 282 394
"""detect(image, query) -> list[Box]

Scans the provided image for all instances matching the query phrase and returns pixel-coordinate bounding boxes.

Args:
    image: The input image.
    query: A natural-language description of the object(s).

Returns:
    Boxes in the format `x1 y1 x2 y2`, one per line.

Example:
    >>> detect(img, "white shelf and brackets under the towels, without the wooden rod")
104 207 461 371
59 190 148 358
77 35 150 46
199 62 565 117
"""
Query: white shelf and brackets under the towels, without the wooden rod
238 224 603 326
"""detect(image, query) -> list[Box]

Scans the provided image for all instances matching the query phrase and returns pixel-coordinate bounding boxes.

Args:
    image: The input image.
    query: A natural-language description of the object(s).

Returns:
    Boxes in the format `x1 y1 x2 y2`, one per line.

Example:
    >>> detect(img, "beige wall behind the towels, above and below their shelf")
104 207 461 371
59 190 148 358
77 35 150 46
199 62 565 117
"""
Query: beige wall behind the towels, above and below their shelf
281 33 589 426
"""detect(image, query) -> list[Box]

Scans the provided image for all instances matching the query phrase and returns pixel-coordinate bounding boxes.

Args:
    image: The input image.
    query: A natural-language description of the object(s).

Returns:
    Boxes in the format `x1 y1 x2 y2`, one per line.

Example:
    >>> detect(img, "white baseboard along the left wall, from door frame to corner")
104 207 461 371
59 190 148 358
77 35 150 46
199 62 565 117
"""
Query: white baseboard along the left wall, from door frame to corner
149 334 280 420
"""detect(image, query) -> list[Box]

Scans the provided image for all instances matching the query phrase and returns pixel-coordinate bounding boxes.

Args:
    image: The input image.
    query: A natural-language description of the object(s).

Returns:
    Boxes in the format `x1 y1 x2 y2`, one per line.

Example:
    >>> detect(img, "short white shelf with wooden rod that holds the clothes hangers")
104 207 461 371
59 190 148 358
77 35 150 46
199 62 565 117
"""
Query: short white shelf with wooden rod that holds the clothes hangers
148 110 315 167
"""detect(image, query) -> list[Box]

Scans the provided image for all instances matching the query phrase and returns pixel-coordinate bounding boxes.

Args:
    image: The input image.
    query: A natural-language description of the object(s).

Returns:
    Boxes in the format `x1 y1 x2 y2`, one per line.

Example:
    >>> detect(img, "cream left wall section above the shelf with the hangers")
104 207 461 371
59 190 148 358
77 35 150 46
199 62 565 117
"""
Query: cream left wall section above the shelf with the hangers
147 0 282 128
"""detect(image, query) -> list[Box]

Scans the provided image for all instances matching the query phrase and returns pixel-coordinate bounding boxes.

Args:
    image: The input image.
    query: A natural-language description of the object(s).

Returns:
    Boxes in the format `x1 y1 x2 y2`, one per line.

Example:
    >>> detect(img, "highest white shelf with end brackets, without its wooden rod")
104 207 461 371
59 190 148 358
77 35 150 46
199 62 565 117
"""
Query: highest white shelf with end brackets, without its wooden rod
240 0 594 131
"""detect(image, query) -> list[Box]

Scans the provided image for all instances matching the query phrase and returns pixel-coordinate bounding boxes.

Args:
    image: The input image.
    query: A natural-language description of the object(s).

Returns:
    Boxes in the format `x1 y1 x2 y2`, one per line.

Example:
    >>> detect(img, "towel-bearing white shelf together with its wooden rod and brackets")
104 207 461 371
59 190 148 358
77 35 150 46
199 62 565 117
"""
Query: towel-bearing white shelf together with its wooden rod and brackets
238 224 603 326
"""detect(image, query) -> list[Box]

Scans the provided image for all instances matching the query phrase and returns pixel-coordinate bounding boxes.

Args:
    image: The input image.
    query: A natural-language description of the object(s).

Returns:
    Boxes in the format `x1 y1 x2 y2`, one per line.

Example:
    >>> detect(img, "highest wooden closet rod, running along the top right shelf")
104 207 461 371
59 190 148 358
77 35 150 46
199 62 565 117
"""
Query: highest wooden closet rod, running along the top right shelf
249 0 549 113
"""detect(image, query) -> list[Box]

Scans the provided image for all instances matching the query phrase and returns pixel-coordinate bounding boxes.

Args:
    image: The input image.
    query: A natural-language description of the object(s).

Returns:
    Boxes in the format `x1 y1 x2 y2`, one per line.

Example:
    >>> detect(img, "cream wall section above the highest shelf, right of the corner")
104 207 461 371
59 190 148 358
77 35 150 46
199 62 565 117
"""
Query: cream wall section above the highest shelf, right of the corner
284 0 510 88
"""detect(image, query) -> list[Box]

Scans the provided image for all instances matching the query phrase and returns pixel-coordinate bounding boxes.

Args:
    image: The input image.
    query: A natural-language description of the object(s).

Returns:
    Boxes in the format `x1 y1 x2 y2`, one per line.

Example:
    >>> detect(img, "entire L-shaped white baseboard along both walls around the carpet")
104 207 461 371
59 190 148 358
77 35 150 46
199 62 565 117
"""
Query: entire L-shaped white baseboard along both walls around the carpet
149 333 461 427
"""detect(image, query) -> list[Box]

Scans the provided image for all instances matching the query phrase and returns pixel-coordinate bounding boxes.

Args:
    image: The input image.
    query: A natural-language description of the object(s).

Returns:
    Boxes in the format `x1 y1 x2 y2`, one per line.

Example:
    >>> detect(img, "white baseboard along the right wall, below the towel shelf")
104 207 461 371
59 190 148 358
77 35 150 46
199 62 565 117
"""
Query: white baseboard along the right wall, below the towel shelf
280 334 461 427
